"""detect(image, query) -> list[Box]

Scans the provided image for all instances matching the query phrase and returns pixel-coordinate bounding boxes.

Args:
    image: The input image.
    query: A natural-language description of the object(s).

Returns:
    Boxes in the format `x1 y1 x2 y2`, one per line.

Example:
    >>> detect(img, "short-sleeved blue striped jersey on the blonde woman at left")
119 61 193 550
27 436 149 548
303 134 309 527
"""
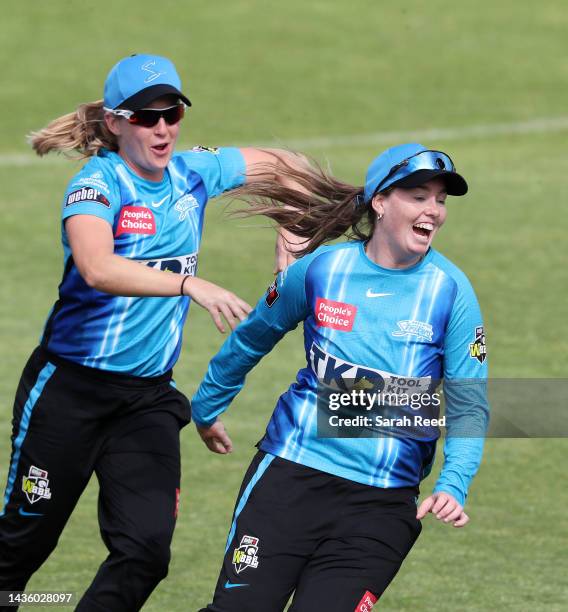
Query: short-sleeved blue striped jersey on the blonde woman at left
42 147 245 376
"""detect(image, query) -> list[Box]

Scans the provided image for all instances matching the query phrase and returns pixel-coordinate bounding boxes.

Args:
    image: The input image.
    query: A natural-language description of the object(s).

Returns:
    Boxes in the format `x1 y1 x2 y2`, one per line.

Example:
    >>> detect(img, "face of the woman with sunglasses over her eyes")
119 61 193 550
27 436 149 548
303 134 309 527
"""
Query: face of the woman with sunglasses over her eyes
105 96 180 181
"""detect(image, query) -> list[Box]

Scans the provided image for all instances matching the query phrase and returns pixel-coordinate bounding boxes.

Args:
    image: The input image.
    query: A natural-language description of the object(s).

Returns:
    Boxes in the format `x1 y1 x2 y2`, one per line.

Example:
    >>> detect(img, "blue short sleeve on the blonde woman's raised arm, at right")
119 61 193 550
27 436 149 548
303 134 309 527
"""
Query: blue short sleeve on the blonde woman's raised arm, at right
181 147 246 198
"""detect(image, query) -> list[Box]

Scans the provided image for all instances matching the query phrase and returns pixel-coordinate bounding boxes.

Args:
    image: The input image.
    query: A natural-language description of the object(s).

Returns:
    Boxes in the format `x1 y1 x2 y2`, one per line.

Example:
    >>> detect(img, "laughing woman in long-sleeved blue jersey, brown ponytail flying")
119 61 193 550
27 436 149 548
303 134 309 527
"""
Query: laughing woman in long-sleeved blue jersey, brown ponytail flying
193 143 488 612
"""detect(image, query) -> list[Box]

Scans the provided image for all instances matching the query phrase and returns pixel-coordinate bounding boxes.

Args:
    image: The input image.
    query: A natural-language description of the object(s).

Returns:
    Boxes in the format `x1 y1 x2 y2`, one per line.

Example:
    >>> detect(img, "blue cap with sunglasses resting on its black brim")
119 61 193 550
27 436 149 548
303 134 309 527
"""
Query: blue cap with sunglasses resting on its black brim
365 142 468 202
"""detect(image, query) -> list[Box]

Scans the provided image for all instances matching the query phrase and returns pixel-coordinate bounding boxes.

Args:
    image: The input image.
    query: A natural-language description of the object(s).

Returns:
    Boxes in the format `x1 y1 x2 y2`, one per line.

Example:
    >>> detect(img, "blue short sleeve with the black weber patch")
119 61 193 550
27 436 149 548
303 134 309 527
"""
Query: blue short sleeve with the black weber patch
62 158 120 225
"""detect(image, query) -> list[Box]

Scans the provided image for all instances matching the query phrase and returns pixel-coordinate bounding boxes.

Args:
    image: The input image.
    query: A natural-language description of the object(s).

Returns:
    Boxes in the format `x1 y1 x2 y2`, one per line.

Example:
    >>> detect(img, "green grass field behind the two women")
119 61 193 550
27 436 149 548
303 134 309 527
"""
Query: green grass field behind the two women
0 0 568 612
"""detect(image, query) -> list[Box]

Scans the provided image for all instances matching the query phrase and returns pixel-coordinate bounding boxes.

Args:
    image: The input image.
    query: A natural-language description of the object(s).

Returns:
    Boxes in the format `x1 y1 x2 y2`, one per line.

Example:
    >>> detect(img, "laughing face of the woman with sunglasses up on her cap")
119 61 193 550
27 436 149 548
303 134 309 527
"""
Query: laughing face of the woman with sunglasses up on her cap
367 178 447 268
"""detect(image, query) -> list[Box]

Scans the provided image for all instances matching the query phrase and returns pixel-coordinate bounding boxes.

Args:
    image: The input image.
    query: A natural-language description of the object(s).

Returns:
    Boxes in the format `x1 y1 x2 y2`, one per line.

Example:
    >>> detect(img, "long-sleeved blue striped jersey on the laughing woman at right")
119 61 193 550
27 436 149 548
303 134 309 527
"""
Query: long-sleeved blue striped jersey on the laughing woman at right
192 242 488 503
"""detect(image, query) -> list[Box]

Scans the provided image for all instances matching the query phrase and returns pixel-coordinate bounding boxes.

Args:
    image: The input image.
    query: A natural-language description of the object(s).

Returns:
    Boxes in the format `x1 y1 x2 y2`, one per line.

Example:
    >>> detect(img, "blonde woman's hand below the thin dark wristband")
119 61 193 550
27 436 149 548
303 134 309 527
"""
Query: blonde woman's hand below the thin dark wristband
183 276 252 334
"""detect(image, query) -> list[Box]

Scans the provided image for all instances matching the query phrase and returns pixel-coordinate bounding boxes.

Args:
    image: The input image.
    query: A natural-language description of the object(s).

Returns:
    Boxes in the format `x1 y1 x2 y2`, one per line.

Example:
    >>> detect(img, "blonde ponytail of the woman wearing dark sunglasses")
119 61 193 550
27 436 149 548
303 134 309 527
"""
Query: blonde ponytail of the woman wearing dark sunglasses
28 100 118 158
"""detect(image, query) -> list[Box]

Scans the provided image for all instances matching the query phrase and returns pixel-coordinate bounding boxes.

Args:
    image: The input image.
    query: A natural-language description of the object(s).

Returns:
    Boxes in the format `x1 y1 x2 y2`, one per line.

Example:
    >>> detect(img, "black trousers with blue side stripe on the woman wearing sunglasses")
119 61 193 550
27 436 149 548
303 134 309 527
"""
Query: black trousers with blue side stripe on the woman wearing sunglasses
0 348 190 612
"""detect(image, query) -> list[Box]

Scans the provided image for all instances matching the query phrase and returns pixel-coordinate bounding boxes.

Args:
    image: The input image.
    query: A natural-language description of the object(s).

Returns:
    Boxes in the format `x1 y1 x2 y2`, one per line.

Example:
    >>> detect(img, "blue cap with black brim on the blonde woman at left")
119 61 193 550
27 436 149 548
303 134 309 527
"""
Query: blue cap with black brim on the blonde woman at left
104 55 191 111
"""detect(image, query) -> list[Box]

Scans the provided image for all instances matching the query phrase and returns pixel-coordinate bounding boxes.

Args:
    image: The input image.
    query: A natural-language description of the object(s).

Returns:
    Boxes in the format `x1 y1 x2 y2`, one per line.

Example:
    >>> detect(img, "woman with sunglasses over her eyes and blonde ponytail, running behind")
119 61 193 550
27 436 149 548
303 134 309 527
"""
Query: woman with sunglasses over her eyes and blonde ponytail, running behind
0 55 306 612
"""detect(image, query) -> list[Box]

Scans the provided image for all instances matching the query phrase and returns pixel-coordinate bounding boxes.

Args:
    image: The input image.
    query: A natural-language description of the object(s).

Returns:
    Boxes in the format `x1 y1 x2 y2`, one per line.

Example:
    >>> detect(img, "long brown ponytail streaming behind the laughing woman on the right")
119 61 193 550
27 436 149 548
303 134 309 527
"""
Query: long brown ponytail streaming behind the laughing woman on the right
231 154 376 257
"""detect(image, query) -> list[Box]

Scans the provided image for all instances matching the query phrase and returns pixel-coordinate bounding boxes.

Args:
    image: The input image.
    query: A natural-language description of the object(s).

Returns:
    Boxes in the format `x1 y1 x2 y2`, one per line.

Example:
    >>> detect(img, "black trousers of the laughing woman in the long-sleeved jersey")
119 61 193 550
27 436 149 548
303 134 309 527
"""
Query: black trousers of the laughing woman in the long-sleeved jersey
200 452 421 612
